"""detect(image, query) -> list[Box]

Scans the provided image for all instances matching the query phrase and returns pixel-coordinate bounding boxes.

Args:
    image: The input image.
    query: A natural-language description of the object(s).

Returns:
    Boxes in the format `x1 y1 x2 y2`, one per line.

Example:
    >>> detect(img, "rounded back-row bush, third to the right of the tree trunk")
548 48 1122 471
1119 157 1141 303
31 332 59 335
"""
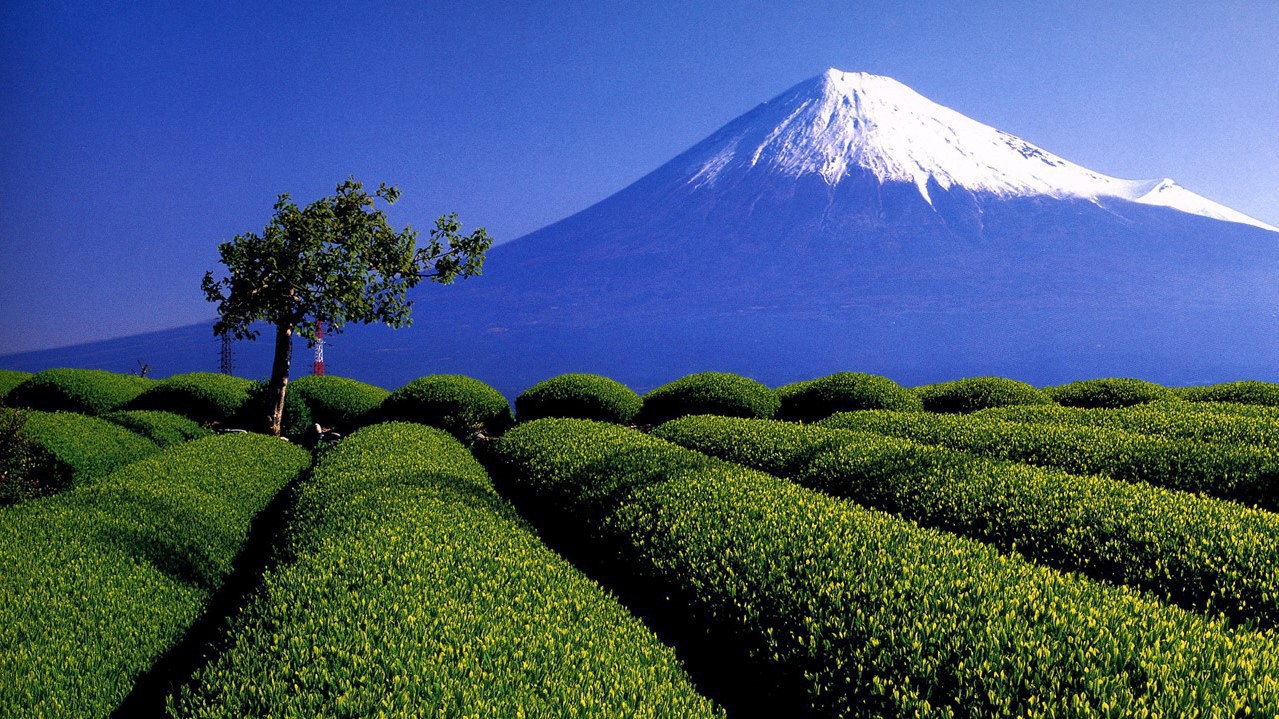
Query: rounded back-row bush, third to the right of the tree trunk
515 374 643 425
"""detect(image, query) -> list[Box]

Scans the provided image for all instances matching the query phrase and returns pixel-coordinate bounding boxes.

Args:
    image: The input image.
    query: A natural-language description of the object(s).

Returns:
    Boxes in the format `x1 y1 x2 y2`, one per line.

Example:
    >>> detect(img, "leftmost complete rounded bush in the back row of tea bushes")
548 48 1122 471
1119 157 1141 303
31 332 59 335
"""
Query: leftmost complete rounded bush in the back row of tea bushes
6 370 155 415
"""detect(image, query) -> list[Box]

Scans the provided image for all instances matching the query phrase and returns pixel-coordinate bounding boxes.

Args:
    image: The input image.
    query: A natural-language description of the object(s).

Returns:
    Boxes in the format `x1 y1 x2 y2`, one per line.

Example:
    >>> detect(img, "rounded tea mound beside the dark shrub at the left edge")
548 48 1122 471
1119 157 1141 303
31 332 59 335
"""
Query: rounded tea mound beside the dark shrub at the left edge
22 412 160 489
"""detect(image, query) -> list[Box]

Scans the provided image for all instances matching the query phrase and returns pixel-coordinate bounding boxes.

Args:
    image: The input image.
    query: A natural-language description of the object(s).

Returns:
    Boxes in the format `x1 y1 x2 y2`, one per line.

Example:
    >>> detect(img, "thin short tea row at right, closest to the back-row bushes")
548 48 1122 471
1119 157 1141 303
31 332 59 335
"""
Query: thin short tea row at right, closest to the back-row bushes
976 403 1279 449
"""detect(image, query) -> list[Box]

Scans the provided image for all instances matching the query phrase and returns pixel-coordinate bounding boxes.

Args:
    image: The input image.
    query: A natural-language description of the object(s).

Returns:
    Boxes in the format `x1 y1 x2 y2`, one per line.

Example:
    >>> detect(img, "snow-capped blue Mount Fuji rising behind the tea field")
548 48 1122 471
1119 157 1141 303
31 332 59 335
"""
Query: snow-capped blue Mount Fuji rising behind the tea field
3 70 1279 395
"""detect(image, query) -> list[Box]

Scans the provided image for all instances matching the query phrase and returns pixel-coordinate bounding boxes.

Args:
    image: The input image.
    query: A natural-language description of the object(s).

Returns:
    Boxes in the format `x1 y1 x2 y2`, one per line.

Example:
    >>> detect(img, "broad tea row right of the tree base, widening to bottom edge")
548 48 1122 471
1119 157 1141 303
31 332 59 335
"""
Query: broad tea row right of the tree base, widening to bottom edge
170 423 718 719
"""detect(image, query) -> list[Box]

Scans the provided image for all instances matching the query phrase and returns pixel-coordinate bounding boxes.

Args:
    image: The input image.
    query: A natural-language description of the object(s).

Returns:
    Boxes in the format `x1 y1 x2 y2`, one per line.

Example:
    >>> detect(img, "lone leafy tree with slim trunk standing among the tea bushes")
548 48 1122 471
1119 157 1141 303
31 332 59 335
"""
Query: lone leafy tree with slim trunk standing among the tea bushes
201 178 492 436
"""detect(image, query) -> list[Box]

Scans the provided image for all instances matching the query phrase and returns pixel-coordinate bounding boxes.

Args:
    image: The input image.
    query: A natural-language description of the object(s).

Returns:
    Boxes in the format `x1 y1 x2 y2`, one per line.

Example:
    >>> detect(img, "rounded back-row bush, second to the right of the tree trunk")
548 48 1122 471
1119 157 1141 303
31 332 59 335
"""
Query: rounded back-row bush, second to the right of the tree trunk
382 375 514 441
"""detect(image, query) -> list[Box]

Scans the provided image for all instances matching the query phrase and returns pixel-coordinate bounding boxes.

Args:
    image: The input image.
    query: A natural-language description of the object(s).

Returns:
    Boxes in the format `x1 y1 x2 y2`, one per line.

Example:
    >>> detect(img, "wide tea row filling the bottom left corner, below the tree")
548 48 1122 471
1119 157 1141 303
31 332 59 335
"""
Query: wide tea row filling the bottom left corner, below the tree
0 435 310 718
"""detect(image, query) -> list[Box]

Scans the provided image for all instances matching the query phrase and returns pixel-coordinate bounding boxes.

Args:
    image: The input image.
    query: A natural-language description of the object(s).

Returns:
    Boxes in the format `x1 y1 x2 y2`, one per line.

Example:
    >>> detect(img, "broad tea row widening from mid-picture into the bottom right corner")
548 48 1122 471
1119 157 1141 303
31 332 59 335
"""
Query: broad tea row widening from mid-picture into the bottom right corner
496 420 1279 716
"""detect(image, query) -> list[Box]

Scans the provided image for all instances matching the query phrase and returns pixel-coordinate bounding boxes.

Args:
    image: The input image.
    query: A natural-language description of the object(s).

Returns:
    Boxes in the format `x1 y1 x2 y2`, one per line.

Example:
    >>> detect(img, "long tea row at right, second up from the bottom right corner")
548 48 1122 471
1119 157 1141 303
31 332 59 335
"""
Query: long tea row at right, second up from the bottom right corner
654 417 1279 627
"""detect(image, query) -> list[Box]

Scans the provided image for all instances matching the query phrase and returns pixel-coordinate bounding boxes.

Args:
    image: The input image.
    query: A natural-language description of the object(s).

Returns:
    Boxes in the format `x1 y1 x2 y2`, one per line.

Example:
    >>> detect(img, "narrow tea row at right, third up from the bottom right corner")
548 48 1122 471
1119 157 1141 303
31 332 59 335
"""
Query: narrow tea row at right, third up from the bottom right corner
821 412 1279 509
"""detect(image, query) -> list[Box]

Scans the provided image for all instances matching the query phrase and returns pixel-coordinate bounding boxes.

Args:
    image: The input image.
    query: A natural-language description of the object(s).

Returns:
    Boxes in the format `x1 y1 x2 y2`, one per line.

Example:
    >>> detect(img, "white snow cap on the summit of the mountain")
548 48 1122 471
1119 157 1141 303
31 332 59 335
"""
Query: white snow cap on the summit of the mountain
687 68 1279 232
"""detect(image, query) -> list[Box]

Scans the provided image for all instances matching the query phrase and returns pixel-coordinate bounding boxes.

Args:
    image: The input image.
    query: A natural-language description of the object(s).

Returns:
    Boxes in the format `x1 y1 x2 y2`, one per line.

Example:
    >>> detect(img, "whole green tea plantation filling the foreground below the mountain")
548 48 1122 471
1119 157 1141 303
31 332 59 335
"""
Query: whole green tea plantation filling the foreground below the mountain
0 370 1279 719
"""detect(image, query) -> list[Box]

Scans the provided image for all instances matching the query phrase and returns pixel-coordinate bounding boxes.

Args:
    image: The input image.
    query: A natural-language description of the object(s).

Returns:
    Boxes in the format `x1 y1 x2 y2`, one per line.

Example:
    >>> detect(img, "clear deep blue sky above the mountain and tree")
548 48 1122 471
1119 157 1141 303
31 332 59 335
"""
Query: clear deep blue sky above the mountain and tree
0 0 1279 353
